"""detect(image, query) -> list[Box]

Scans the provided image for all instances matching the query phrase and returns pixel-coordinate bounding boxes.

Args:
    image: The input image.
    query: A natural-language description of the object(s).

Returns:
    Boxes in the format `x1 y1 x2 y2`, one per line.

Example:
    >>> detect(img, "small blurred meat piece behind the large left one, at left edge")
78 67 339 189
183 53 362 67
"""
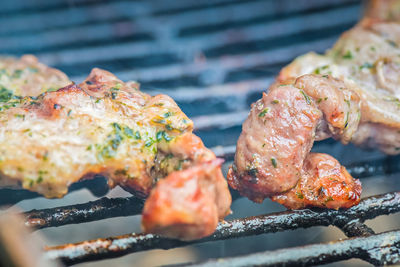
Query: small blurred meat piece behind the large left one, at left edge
0 55 71 98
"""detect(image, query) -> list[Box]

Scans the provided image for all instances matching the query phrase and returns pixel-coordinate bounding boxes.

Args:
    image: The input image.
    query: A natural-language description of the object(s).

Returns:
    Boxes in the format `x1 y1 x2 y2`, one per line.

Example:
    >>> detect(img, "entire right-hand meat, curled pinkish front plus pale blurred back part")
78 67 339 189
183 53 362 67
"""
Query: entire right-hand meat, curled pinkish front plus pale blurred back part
228 6 400 209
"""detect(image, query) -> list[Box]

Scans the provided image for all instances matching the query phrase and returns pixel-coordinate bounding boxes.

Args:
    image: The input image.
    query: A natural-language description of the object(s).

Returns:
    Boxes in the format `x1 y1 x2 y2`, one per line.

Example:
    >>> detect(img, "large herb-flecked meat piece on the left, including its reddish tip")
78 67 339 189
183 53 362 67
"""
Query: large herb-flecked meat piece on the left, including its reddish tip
0 69 231 239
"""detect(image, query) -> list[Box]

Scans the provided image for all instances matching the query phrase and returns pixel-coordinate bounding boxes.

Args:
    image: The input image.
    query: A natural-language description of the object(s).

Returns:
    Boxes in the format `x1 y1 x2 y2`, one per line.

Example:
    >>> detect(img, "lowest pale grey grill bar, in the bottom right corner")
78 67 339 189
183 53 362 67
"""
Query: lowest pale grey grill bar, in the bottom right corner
180 231 400 267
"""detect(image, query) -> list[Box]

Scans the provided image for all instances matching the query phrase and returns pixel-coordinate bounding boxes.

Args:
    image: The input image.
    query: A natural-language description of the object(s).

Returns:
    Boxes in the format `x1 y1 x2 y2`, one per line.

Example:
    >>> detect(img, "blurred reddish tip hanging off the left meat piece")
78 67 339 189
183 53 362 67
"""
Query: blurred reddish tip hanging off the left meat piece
142 159 231 240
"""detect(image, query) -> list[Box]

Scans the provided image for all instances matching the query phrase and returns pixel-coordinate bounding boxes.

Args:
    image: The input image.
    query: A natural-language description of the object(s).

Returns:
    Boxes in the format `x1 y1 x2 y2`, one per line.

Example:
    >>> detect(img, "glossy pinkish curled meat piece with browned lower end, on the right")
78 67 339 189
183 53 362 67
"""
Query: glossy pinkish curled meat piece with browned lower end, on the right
228 75 361 209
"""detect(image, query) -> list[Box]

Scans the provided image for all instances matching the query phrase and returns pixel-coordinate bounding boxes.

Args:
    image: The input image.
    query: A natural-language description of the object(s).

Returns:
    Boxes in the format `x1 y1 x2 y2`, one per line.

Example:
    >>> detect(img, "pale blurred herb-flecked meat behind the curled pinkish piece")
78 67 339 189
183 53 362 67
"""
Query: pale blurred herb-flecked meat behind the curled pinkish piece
278 17 400 154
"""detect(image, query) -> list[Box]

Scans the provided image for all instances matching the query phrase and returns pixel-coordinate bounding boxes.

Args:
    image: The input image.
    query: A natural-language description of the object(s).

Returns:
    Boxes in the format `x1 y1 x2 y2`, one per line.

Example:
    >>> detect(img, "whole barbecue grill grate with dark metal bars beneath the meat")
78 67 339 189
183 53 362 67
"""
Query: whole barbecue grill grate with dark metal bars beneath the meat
0 0 400 266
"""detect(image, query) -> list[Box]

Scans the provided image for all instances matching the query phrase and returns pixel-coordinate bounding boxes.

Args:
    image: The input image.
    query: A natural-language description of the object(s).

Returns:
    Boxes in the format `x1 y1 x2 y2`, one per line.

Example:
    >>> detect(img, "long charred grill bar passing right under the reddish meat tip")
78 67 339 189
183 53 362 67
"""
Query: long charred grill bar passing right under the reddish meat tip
46 192 400 264
